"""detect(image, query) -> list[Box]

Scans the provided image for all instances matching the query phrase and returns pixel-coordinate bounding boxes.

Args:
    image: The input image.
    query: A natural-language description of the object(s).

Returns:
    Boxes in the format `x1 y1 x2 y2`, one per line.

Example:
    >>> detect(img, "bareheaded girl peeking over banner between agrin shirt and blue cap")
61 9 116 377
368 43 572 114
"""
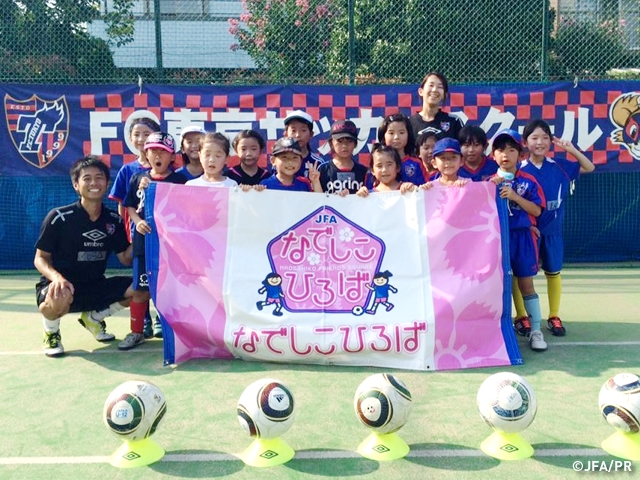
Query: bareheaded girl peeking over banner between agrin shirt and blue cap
356 143 416 197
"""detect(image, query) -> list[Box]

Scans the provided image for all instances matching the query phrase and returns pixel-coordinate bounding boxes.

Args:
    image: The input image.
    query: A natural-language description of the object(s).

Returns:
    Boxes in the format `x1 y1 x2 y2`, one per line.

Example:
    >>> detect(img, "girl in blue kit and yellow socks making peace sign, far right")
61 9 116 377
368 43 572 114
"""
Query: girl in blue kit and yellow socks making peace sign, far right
514 120 595 336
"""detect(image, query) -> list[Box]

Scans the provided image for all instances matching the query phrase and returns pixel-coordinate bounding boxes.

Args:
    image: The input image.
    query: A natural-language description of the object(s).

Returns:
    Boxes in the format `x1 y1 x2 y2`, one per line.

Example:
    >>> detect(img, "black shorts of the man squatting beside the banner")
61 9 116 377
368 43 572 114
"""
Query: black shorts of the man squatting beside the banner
36 276 131 312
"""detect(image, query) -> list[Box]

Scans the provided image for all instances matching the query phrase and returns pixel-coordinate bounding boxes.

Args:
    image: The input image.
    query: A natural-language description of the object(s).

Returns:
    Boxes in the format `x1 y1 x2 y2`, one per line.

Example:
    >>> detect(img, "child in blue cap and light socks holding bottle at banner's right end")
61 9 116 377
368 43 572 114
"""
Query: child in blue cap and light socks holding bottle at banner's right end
490 129 547 352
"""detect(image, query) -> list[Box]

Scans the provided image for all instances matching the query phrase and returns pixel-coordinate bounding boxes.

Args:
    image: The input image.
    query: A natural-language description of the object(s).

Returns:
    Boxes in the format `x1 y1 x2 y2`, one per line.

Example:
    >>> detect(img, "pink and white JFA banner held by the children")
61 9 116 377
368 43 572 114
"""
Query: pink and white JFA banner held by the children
146 183 522 370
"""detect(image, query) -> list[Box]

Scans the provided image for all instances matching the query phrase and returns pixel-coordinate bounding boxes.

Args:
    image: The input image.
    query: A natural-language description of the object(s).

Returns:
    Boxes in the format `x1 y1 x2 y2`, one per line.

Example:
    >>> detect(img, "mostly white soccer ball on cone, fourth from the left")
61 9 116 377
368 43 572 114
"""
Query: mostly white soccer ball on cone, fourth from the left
476 372 538 433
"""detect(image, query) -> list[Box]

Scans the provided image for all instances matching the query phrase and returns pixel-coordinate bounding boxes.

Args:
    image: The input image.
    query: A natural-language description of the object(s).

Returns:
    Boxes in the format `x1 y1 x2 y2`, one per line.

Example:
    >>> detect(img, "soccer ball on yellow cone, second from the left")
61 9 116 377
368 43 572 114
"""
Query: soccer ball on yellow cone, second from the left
238 378 295 439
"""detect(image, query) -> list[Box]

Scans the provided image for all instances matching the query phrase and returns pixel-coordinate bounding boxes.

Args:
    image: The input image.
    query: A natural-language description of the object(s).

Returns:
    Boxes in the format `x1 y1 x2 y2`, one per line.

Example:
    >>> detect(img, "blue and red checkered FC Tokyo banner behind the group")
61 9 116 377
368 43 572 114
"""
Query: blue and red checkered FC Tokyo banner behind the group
0 82 640 176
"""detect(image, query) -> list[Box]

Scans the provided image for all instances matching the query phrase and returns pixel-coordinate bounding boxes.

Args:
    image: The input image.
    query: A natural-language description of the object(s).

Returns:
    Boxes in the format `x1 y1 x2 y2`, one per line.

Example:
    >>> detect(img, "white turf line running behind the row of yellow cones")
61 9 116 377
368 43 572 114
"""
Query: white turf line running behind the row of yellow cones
0 448 609 465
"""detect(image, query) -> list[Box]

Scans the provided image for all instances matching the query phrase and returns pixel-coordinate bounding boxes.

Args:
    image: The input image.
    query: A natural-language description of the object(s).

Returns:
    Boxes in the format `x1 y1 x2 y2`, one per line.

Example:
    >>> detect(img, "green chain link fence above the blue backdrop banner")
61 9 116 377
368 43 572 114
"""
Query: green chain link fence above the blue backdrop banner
0 0 640 85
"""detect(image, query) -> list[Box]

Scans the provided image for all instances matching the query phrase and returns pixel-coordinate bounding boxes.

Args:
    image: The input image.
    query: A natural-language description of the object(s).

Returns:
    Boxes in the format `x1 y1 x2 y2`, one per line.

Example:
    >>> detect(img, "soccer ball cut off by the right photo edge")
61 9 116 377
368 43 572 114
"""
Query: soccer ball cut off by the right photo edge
598 373 640 433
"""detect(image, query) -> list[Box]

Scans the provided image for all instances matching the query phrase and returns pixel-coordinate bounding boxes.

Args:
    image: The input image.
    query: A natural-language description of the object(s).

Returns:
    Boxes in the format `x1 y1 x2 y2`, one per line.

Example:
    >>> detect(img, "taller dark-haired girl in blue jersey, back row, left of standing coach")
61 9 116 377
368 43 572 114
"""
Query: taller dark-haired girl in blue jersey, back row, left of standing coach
378 113 426 186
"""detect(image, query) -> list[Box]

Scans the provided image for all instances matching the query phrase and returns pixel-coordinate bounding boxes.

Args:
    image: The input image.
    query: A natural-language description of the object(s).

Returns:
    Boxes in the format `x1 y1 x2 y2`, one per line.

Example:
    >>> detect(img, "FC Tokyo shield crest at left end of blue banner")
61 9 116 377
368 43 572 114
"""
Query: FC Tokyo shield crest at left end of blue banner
4 94 69 168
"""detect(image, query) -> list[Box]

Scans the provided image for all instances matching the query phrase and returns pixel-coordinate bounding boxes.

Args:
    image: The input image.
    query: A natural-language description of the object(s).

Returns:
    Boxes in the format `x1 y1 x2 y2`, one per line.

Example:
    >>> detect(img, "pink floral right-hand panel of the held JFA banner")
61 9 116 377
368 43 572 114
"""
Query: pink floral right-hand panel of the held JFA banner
424 183 511 370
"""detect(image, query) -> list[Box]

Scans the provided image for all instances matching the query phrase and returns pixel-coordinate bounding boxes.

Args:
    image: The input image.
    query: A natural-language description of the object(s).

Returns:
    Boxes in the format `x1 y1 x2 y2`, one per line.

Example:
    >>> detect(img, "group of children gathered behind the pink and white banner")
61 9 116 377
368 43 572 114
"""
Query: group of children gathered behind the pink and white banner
104 90 594 351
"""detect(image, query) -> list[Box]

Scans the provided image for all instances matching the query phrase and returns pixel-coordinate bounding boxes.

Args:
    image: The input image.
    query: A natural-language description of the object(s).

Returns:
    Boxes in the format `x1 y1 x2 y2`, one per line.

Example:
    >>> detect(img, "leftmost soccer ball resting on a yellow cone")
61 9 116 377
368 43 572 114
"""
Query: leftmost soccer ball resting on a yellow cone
102 380 167 442
